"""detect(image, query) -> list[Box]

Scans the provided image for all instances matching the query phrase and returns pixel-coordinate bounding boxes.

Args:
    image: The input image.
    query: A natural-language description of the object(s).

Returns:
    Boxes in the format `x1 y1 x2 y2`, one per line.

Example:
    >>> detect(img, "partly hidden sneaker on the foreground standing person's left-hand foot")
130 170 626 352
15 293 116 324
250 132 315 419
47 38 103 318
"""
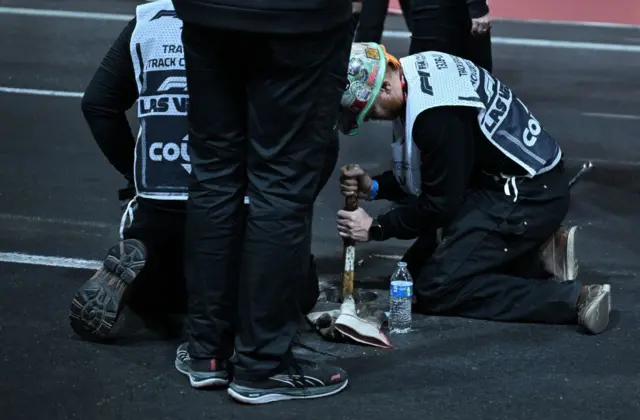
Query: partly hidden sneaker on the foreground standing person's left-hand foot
175 343 229 388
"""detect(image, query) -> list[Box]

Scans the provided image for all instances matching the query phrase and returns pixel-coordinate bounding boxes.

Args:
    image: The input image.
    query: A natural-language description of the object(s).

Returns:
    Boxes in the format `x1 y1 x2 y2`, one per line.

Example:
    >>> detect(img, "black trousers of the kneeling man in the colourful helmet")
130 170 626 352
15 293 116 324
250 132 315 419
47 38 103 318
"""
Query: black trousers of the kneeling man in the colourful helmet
404 167 581 324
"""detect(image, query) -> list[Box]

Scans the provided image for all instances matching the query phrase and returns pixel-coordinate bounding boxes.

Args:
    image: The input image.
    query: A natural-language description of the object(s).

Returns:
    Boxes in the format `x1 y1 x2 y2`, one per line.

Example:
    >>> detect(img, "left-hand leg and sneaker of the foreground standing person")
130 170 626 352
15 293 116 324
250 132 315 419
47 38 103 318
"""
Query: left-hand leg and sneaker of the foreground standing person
176 22 251 387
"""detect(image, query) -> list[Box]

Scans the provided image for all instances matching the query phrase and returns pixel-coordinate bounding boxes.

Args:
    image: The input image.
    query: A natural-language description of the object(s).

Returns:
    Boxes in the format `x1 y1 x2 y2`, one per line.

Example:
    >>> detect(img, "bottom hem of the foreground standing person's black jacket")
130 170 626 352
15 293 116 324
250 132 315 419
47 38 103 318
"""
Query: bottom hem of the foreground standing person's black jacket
173 0 351 34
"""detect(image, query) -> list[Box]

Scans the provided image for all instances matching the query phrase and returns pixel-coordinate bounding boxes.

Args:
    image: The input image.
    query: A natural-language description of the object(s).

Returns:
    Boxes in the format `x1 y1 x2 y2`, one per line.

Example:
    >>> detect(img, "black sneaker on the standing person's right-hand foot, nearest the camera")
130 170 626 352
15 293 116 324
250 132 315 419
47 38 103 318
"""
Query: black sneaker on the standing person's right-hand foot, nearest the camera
227 359 349 404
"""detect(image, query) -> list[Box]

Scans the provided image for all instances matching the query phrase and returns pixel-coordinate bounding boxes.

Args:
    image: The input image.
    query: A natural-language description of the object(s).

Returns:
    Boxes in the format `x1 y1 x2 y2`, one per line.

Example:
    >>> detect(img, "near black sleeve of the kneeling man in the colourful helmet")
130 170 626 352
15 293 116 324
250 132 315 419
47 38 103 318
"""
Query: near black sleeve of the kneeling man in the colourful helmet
378 107 475 239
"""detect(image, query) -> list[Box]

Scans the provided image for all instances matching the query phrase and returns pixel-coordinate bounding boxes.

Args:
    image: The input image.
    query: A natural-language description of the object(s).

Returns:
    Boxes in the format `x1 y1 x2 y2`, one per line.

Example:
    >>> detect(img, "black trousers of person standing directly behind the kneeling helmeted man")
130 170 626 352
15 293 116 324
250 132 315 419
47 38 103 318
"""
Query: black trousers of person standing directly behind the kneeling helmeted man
409 0 493 72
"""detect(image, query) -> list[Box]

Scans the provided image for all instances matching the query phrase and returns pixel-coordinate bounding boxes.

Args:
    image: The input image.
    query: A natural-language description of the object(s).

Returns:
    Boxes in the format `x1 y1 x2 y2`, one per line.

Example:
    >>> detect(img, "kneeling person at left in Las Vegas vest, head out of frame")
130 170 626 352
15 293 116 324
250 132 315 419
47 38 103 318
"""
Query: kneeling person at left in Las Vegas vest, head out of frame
69 0 324 340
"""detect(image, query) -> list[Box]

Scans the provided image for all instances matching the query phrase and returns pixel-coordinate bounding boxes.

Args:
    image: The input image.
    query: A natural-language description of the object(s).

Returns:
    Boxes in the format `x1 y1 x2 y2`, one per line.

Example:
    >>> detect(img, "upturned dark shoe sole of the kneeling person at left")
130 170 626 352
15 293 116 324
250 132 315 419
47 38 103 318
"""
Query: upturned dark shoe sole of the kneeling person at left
69 239 147 340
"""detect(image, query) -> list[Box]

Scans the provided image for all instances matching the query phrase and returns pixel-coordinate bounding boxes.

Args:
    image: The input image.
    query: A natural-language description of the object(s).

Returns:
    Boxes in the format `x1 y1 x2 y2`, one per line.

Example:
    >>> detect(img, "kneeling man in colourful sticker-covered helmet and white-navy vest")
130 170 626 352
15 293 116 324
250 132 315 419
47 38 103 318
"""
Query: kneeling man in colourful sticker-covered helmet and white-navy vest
337 43 611 334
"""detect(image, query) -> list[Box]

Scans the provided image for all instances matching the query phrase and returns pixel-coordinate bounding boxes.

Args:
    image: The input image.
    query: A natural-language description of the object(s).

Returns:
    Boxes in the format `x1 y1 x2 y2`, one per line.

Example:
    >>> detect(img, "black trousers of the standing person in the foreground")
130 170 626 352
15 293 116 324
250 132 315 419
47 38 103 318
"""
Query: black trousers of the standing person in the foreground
182 22 349 380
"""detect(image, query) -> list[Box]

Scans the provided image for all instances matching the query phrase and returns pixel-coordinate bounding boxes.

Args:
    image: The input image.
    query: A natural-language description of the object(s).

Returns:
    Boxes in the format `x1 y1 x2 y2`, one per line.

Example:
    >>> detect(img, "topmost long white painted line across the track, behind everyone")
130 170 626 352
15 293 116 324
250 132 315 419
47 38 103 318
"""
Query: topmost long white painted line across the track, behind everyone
0 6 640 53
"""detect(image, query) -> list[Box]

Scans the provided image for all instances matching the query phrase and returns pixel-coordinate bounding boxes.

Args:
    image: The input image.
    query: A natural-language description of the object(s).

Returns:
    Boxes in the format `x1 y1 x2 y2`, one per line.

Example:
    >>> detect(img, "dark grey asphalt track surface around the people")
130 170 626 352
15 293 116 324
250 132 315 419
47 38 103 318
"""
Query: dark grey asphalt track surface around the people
0 0 640 420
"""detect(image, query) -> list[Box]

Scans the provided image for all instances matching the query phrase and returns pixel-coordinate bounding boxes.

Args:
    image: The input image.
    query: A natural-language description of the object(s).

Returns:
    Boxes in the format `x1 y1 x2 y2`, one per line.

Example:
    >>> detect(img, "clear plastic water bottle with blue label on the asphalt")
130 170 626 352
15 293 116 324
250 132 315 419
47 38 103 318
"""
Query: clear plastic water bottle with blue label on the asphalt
389 262 413 333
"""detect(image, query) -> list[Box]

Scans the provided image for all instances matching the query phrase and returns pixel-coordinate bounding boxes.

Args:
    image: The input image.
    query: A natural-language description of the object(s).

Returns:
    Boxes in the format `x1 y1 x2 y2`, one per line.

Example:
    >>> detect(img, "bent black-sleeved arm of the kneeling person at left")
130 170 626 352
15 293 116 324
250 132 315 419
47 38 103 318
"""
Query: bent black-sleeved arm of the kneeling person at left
82 19 138 181
